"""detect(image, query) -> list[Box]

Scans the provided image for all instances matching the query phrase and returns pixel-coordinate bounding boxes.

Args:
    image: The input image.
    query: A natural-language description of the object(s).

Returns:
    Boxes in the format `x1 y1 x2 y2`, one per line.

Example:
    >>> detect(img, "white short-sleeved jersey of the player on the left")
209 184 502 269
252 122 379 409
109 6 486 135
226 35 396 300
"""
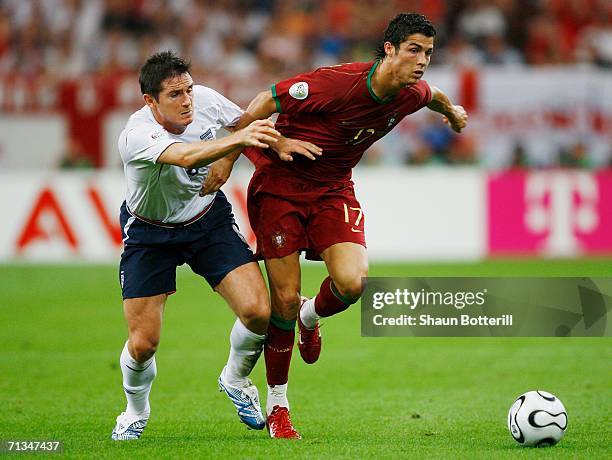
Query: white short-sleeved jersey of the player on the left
118 85 242 224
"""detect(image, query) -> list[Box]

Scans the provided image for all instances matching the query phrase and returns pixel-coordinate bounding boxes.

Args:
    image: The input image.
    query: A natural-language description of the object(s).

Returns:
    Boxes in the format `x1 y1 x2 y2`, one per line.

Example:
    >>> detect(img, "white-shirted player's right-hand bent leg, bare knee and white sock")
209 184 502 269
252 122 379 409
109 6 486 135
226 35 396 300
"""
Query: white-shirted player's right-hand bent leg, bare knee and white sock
215 262 270 387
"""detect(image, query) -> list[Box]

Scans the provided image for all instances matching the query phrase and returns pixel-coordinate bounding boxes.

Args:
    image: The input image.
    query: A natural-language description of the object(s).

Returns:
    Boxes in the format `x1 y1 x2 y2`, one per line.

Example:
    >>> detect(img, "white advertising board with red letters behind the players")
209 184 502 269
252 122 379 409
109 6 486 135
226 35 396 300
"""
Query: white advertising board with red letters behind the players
0 168 486 263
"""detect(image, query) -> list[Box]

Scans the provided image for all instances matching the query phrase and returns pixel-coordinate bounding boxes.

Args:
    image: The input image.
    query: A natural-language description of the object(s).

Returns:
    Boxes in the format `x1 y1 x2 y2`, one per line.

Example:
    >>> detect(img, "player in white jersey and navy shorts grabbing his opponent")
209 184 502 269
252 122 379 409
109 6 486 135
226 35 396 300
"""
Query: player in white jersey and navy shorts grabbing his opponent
111 51 320 440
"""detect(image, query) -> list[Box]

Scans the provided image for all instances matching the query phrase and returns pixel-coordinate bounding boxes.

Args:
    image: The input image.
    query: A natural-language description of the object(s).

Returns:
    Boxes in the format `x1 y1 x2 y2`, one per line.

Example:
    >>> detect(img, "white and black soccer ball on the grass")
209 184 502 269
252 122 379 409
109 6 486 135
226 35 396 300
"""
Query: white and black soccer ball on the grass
508 390 567 447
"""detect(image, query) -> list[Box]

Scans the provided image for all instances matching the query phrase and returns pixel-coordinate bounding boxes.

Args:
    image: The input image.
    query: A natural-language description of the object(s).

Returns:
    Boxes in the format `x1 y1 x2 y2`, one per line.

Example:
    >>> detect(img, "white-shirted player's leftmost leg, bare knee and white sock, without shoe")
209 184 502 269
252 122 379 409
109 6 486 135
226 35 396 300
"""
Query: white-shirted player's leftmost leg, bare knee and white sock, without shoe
119 294 168 417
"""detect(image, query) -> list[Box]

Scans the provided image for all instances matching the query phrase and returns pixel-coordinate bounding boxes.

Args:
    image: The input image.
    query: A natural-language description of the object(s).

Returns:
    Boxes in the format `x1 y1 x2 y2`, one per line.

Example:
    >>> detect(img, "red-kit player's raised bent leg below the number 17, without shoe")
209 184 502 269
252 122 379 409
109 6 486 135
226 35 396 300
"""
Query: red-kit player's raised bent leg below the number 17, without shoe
300 243 368 329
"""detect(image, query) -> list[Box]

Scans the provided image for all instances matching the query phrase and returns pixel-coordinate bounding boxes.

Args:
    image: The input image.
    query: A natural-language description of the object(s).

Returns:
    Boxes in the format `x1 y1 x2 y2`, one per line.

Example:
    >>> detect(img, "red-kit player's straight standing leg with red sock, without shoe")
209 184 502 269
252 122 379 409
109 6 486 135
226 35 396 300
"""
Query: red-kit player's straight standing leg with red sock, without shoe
264 252 301 414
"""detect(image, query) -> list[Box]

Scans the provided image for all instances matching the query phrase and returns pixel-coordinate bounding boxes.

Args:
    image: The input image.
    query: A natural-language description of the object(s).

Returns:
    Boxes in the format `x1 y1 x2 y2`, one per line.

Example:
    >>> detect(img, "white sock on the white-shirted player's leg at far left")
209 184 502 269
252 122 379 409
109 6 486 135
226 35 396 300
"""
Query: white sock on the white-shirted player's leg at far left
119 342 157 417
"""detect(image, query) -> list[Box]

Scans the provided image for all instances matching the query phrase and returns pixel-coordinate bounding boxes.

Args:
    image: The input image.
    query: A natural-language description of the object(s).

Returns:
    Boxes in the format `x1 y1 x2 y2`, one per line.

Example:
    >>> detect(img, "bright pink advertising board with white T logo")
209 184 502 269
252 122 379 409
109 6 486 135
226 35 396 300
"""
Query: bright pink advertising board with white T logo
488 171 612 256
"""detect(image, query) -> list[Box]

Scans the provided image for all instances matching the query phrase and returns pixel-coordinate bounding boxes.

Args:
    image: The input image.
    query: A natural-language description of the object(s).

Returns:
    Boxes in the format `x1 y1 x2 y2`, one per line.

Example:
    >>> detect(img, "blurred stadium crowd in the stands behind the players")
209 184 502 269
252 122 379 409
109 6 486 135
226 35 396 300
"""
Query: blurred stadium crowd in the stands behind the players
0 0 612 169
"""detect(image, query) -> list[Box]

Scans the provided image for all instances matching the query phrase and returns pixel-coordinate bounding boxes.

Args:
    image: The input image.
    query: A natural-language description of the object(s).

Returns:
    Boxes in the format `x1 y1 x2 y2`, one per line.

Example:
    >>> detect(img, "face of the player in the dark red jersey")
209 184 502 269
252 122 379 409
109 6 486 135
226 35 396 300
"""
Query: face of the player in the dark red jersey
385 34 433 86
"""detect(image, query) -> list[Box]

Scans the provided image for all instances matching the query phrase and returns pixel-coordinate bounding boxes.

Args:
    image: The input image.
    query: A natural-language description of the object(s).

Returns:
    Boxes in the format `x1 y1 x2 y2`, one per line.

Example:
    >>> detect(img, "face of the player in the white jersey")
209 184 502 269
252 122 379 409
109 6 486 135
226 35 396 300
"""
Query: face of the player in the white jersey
145 73 193 134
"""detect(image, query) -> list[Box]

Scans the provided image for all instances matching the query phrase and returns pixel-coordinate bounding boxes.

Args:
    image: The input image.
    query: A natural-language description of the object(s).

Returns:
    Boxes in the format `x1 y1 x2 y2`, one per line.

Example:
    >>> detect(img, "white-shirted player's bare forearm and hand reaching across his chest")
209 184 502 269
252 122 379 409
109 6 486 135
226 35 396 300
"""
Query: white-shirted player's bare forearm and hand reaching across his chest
157 120 280 169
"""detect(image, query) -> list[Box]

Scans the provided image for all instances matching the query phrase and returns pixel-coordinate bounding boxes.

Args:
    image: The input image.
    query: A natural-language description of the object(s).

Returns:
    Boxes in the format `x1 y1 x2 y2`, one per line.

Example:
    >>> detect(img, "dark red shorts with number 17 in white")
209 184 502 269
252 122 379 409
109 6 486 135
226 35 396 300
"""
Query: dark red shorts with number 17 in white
247 167 366 260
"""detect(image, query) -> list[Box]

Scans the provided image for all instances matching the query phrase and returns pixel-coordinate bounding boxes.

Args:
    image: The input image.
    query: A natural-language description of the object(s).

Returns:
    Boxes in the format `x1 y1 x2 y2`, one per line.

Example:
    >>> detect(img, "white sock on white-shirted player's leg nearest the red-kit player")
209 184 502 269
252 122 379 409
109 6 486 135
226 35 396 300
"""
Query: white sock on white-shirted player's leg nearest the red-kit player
223 318 266 387
